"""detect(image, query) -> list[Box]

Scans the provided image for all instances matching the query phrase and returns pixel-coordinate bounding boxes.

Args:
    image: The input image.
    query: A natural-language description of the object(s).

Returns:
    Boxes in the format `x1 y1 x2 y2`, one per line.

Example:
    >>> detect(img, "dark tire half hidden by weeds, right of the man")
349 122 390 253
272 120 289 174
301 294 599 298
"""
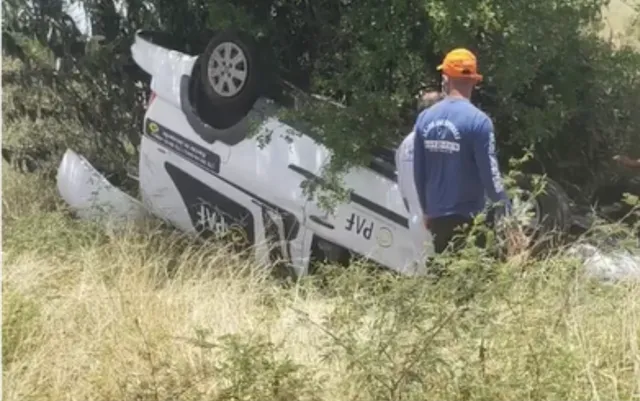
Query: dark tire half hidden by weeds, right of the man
516 175 573 250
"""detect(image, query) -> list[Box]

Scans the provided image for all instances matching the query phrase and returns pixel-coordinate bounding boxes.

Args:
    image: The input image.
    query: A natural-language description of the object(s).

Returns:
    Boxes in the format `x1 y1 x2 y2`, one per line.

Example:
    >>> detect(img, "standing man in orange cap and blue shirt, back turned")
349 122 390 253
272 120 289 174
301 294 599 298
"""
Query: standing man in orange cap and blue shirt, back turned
414 48 510 253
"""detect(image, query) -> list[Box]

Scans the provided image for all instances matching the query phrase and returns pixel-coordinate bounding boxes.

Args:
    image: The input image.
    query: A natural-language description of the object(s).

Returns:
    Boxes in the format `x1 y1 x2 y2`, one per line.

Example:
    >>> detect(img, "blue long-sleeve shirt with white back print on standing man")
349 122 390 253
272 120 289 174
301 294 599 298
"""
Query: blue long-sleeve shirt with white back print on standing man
413 98 510 218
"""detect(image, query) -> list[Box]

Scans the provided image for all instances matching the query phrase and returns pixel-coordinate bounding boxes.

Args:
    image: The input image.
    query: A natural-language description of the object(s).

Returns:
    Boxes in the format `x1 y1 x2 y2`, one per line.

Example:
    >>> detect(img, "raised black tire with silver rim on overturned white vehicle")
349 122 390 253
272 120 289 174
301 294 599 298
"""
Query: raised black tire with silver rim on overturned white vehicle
199 28 264 125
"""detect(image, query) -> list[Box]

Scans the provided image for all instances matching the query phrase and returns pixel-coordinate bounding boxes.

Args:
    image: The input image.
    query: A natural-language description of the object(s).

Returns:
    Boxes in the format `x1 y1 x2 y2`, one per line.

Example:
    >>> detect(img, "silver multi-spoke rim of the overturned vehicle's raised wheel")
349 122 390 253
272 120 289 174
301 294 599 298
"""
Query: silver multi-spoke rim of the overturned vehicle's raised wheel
207 42 248 97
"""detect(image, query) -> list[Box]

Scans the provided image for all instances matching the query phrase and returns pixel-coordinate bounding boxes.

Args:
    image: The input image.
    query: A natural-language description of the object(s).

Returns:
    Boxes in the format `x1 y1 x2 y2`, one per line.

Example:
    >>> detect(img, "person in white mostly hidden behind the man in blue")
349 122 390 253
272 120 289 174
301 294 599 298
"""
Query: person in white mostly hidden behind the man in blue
395 91 443 265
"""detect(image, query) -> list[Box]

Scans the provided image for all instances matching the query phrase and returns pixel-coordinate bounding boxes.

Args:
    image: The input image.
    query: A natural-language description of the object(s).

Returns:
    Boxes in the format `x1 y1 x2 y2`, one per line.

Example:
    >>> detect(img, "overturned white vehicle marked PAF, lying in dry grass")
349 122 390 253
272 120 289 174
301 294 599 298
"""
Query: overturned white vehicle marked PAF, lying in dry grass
58 30 571 276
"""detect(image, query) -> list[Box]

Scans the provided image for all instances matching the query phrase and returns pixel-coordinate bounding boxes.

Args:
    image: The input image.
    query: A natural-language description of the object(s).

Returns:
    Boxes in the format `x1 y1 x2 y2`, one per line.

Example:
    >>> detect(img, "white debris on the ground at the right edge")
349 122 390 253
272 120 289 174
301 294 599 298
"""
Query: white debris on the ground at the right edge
569 244 640 282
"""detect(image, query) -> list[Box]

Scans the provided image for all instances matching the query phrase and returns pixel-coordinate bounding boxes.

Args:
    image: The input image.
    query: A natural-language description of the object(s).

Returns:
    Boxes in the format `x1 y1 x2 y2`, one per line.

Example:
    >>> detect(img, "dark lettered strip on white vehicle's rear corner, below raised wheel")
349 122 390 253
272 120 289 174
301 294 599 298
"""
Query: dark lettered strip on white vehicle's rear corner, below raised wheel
145 119 220 174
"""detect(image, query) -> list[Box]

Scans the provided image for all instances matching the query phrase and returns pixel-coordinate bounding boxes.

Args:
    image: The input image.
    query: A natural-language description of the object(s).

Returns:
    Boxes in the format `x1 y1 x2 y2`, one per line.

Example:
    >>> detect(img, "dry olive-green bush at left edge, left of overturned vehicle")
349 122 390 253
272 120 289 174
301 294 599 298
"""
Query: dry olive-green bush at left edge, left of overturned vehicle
2 38 143 181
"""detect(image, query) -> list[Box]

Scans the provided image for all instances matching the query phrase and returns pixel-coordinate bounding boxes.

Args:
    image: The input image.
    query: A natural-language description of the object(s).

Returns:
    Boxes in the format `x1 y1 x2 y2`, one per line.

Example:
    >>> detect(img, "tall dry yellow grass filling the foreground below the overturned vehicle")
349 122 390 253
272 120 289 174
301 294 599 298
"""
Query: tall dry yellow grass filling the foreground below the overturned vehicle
2 163 640 401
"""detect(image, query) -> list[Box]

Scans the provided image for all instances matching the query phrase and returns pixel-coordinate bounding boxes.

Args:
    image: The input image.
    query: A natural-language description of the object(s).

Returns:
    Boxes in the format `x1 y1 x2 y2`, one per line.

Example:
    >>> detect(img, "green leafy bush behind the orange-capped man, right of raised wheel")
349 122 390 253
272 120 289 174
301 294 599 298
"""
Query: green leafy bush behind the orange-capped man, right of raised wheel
232 0 640 198
